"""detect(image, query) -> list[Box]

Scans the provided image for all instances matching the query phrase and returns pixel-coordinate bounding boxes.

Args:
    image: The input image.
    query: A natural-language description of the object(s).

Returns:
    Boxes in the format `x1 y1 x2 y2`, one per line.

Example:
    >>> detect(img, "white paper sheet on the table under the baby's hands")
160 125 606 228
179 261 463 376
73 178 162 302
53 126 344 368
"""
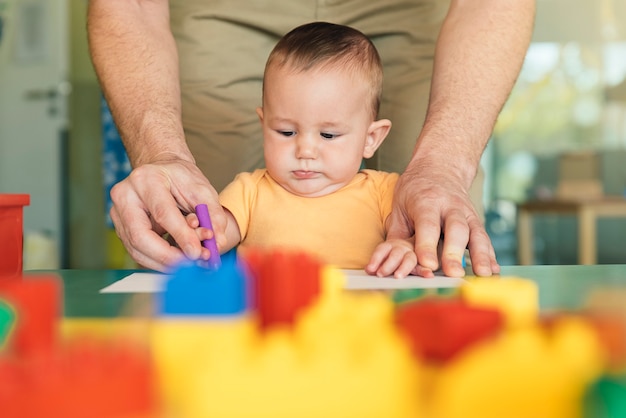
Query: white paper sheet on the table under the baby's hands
100 270 464 293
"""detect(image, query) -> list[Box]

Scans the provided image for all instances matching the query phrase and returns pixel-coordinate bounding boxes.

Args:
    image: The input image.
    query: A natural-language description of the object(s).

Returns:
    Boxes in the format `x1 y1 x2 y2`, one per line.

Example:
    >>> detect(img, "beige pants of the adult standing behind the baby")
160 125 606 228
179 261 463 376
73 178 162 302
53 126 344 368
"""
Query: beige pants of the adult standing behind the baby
170 0 482 219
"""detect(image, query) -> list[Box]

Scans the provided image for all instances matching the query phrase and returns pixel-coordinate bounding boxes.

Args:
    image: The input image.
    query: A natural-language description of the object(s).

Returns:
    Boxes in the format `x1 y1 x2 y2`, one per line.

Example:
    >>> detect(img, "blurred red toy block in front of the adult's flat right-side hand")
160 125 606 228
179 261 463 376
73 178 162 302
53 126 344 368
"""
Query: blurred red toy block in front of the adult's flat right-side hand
396 298 504 362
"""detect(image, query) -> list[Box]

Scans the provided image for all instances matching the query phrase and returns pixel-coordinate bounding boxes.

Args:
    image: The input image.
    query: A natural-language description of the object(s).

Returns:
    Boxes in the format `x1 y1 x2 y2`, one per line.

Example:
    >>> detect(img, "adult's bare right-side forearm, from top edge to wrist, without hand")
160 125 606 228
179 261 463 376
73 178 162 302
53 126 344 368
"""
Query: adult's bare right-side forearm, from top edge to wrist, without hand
414 0 535 187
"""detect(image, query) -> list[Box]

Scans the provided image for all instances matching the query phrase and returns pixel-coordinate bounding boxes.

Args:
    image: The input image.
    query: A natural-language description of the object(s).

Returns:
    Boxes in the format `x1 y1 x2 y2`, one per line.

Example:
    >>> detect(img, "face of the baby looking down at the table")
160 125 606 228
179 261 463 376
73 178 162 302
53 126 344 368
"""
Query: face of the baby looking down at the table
259 63 373 197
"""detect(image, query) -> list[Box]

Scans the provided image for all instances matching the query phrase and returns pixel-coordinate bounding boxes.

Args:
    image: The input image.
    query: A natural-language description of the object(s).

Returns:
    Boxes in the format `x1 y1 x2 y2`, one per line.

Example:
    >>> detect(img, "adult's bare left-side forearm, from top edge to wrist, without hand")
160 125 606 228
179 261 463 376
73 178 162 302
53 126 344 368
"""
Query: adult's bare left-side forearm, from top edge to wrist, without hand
88 0 193 167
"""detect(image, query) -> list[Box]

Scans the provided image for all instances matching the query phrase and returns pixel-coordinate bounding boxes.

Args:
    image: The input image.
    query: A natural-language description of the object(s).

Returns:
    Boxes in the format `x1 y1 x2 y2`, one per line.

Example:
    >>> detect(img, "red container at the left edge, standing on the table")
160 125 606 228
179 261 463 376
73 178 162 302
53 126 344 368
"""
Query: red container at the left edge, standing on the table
0 193 30 277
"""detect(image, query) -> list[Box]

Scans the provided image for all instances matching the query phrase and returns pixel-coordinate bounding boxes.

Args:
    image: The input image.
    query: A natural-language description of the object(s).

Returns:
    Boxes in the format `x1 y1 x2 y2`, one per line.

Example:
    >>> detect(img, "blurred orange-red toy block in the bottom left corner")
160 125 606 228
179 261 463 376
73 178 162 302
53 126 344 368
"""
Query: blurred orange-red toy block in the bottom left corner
0 338 156 418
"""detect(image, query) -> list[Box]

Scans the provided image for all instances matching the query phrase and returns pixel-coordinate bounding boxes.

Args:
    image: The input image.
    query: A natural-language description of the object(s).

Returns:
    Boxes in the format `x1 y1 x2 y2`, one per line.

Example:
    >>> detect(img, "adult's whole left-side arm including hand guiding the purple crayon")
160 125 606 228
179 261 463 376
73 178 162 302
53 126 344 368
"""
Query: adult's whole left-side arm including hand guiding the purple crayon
87 0 225 270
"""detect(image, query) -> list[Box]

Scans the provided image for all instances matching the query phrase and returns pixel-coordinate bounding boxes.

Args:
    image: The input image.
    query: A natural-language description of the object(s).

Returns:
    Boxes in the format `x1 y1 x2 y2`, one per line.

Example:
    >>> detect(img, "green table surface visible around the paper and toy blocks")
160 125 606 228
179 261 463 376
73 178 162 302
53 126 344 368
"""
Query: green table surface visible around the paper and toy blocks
24 264 626 318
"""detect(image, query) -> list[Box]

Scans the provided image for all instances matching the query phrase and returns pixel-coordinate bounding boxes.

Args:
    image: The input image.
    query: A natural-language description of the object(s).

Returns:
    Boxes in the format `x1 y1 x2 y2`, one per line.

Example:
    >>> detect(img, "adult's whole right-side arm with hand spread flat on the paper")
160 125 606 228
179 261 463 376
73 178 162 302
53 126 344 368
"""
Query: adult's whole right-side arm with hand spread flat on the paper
389 0 535 276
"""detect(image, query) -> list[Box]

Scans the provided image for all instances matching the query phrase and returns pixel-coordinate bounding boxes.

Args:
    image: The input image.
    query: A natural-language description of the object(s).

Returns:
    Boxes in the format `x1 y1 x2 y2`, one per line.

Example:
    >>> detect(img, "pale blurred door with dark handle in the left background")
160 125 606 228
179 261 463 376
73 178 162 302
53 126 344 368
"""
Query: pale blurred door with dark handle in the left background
0 0 70 268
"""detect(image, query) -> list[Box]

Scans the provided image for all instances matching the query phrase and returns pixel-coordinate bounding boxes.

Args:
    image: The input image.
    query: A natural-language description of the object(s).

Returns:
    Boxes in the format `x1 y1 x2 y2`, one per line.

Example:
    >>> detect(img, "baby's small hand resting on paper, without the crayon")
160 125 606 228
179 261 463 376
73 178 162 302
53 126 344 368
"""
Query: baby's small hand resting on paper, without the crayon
365 239 434 279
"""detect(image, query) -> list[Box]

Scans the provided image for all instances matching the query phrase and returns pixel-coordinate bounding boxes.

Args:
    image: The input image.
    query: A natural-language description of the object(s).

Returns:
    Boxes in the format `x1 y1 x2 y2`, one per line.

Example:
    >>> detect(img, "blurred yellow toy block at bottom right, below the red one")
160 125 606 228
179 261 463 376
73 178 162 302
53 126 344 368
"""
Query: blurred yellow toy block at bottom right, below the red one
429 318 603 418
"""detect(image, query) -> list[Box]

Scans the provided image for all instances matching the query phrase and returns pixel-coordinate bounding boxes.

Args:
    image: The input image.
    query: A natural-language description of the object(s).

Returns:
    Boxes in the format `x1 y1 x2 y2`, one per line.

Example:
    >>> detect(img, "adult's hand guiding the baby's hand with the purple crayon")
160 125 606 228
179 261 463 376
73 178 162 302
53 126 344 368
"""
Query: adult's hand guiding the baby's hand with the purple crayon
111 160 226 271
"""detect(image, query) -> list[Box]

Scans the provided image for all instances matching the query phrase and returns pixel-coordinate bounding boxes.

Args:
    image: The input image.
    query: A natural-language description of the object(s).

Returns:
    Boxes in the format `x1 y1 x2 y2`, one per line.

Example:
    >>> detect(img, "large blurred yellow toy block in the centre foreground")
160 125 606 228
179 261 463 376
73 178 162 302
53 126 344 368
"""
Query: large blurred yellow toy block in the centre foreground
152 269 421 418
